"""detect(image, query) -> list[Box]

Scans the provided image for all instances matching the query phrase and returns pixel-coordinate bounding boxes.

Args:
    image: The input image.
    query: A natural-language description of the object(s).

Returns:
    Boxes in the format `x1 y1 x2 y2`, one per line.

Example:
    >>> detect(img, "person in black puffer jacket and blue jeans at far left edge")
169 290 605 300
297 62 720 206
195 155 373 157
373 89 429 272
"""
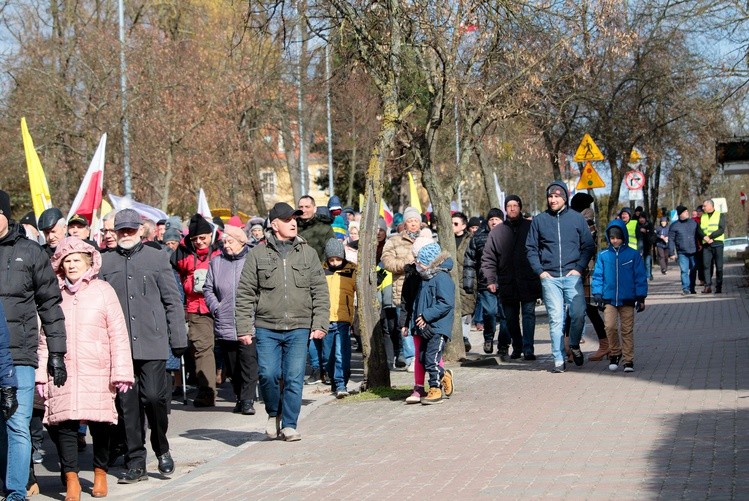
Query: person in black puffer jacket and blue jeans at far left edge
0 191 67 499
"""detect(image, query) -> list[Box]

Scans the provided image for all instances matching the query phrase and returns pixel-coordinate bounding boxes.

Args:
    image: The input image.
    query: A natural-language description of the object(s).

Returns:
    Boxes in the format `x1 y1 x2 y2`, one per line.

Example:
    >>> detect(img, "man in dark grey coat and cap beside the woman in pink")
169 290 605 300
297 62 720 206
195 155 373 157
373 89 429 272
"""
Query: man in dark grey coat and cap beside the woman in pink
100 209 187 484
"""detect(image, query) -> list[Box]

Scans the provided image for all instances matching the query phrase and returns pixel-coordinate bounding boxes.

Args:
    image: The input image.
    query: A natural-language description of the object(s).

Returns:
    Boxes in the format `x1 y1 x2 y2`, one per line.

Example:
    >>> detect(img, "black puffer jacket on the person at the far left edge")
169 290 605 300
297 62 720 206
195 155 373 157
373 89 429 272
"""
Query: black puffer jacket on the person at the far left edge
0 223 67 368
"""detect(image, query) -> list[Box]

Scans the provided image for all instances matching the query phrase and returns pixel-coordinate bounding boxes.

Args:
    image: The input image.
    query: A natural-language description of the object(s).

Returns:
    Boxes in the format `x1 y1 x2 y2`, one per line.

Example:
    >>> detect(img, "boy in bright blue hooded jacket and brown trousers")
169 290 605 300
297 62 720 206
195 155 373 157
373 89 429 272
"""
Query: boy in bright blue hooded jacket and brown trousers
591 219 648 372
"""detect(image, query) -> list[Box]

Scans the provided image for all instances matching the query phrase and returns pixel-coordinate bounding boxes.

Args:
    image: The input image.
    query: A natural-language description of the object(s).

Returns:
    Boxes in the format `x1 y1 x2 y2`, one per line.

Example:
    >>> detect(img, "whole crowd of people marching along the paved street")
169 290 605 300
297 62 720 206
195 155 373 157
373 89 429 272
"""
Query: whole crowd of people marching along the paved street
0 185 725 500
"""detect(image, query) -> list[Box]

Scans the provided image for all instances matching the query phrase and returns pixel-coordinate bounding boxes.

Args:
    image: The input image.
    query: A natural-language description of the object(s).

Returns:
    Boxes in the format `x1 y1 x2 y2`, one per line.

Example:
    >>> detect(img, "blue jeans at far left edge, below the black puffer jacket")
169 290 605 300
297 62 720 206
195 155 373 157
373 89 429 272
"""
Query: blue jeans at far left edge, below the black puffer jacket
0 365 34 499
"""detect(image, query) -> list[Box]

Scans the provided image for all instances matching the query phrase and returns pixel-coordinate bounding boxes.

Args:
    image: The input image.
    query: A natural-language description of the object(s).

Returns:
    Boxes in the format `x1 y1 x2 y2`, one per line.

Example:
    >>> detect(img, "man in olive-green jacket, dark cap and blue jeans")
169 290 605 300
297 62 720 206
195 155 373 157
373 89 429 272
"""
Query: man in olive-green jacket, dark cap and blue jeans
236 202 330 442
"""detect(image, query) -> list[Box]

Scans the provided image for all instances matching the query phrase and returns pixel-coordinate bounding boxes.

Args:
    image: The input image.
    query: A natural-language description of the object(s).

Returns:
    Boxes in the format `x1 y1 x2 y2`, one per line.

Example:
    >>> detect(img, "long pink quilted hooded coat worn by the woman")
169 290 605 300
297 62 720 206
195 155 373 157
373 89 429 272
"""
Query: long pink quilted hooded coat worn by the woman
36 237 133 424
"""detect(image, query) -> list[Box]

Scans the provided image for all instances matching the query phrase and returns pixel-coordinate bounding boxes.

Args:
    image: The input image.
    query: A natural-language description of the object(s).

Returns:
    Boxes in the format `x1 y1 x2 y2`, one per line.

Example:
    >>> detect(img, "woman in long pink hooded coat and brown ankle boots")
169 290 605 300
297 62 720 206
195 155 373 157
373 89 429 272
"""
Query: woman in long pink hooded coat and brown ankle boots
36 237 133 500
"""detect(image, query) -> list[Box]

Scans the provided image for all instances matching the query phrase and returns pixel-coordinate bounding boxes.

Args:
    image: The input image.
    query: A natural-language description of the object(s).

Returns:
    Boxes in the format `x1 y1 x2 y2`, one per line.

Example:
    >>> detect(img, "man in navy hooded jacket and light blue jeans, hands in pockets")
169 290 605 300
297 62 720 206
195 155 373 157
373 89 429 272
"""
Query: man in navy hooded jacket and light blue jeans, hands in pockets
526 181 596 372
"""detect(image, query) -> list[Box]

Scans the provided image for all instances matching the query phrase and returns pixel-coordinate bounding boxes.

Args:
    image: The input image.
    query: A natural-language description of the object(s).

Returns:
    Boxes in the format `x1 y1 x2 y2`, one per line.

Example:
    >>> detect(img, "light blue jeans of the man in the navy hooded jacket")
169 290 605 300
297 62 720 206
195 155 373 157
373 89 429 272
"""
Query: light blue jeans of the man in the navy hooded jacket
541 275 585 364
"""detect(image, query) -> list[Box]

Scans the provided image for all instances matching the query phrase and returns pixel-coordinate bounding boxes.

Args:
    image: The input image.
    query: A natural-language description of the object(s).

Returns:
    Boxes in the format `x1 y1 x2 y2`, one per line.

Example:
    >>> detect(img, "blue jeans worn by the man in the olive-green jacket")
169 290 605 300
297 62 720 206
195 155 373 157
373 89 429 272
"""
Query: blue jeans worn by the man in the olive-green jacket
255 327 310 429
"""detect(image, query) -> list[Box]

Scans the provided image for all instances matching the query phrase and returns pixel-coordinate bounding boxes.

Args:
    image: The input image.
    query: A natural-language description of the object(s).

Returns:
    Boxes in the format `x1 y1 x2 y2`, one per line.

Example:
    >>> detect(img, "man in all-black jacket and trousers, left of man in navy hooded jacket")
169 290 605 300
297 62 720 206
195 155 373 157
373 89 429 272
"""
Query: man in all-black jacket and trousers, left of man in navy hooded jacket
481 195 541 360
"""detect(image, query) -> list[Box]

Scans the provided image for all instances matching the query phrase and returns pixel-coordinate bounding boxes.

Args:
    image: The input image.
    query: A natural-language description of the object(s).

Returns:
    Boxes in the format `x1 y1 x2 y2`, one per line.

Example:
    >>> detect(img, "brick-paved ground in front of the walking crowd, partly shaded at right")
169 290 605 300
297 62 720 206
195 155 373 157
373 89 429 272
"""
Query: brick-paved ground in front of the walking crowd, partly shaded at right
29 264 749 500
